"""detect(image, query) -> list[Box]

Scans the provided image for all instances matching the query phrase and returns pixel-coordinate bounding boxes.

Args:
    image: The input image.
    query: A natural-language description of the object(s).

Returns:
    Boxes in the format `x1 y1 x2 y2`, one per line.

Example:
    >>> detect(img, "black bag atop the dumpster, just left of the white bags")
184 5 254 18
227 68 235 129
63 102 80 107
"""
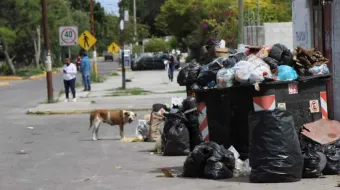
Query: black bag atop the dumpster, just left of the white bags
197 60 222 86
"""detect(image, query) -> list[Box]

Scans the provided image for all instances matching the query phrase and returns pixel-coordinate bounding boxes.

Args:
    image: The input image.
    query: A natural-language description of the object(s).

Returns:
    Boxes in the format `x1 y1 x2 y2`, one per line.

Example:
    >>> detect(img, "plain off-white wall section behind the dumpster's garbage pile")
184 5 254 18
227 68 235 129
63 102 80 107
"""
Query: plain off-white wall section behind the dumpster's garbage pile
264 22 294 51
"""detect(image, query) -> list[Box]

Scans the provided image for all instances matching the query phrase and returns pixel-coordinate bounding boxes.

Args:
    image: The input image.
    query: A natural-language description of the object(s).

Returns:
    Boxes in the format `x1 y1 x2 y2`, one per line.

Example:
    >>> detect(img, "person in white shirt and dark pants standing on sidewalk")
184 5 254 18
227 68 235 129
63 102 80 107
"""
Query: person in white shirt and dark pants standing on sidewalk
63 58 77 102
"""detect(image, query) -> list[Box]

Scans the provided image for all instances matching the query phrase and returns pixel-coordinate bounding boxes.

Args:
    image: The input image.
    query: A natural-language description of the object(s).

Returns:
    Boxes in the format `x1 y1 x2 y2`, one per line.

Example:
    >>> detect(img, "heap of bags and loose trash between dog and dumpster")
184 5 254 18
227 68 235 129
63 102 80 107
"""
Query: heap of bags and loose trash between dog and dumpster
136 97 203 156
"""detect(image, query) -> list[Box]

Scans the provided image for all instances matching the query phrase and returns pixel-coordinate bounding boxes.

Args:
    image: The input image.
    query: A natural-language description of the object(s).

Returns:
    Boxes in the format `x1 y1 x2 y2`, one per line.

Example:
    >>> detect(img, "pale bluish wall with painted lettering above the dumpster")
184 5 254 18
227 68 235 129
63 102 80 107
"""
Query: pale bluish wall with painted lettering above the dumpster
292 0 314 48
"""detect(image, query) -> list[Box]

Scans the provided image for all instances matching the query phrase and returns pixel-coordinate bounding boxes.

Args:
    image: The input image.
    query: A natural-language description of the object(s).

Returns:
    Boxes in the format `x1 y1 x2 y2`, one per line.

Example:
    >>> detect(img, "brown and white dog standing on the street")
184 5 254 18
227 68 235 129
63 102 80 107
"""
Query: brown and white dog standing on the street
89 109 137 141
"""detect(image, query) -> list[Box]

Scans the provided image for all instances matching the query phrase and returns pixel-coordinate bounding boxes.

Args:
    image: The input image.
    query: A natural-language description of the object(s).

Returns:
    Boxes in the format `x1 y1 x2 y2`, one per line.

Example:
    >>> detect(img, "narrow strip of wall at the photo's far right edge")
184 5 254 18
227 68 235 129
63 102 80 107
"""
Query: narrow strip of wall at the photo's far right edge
332 1 340 120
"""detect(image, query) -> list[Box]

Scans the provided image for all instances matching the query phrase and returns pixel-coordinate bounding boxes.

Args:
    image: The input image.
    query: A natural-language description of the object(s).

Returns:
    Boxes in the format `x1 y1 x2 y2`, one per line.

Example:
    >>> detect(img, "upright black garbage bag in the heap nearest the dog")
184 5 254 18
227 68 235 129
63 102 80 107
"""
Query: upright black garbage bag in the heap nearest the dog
162 112 190 156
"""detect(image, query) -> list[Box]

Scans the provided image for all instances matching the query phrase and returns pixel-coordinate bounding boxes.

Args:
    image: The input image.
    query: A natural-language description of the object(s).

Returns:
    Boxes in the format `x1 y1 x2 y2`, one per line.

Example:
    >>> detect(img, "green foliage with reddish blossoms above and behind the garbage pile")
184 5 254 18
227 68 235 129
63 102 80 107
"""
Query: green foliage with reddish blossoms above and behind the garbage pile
156 0 291 48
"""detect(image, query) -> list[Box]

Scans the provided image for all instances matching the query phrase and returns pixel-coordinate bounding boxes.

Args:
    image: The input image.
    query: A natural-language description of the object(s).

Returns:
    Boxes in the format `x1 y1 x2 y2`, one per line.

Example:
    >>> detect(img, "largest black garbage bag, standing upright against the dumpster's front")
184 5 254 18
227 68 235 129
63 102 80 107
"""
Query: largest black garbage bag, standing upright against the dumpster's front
248 109 303 183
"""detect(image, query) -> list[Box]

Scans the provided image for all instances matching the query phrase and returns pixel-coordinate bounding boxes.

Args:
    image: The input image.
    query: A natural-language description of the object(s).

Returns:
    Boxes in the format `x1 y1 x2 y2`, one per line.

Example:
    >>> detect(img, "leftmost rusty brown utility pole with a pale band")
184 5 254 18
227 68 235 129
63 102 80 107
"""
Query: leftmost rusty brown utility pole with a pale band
41 0 54 103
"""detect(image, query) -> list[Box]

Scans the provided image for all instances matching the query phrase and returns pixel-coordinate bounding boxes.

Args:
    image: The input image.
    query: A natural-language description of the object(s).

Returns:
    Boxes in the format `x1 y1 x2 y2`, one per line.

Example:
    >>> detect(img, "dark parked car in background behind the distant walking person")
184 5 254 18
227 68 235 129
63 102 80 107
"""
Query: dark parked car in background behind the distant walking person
131 53 180 71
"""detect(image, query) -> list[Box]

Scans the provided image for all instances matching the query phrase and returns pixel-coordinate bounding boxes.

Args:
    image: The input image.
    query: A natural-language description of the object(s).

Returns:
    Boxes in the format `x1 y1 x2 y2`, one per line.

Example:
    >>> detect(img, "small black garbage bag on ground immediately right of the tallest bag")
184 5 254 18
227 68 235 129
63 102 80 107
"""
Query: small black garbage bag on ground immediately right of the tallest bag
302 144 322 178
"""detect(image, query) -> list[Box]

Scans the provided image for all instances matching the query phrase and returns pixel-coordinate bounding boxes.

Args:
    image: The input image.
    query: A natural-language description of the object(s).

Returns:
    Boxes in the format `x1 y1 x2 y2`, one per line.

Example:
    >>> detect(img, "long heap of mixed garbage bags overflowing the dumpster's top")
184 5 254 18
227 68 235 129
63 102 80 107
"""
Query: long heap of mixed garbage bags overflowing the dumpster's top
177 44 329 89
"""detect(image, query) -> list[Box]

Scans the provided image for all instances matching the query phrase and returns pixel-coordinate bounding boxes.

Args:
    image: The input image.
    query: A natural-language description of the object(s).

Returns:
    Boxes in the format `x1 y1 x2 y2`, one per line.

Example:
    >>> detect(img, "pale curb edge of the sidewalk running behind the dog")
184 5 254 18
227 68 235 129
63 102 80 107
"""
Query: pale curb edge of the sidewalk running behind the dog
26 108 151 115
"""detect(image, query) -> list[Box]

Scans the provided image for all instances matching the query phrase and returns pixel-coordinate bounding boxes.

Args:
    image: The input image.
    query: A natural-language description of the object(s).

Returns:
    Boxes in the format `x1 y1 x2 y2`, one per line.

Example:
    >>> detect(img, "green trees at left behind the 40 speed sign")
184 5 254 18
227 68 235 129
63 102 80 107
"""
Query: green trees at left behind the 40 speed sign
0 0 123 73
